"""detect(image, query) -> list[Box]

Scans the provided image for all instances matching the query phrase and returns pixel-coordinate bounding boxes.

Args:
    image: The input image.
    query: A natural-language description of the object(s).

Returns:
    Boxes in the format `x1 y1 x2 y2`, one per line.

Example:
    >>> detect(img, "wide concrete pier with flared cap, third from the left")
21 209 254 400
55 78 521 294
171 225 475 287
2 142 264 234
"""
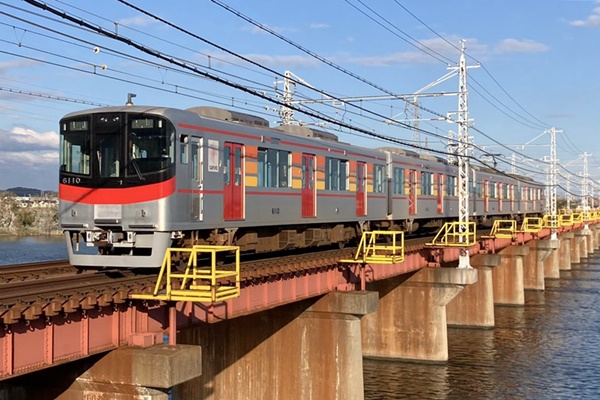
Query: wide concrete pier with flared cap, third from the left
361 268 478 362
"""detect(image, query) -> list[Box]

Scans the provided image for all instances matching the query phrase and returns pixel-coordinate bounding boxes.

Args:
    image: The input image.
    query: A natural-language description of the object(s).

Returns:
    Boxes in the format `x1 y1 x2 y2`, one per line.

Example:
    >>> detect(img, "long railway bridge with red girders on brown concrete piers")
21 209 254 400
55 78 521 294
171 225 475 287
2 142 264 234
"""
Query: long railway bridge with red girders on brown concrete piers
0 216 600 400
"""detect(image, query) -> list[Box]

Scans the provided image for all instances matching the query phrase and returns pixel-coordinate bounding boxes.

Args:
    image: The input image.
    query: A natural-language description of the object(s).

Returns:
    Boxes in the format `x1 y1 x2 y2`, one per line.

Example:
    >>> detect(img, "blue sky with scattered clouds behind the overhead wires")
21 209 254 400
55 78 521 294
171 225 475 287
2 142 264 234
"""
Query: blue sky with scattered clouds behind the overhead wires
0 0 600 193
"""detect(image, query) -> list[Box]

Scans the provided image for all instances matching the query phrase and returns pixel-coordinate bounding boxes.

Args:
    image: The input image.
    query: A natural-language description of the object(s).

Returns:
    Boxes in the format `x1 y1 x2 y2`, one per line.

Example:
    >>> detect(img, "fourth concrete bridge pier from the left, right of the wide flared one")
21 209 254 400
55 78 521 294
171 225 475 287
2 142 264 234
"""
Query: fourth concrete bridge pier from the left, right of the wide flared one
446 254 501 328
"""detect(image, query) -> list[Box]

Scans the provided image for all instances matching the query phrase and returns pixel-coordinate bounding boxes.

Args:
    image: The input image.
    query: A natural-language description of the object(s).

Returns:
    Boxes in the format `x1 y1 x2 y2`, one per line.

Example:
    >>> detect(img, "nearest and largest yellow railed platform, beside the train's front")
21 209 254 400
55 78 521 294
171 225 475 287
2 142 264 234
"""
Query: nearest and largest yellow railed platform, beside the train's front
129 245 240 303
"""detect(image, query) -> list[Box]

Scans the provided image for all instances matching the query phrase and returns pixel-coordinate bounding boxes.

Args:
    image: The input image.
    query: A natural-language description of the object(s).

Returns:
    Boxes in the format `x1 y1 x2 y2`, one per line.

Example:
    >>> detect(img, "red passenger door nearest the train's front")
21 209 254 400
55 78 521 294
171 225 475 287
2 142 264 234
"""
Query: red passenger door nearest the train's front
223 142 244 220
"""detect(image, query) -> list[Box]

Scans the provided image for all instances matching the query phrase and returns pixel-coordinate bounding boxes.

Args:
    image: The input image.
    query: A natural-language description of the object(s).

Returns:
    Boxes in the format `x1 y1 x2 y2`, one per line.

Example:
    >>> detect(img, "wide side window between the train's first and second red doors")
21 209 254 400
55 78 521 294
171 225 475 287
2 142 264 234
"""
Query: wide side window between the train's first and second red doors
257 148 291 188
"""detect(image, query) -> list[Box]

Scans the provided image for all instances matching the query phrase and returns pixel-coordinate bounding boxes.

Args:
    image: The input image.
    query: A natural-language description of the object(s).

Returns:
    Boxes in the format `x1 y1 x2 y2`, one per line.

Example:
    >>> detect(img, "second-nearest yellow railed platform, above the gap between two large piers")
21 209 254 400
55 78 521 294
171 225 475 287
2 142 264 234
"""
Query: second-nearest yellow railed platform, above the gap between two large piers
340 231 404 264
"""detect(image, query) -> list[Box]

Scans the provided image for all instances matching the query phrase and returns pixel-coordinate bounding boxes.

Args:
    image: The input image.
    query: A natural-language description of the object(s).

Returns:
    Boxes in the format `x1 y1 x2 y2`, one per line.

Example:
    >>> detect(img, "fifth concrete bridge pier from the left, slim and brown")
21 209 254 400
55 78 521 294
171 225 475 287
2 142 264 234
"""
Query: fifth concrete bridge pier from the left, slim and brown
492 246 529 305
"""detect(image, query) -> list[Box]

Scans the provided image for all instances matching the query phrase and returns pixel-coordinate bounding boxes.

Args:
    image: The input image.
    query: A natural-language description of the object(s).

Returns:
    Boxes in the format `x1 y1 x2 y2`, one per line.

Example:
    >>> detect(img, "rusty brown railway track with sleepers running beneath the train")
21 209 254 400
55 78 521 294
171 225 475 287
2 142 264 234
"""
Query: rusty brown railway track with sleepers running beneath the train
0 233 478 325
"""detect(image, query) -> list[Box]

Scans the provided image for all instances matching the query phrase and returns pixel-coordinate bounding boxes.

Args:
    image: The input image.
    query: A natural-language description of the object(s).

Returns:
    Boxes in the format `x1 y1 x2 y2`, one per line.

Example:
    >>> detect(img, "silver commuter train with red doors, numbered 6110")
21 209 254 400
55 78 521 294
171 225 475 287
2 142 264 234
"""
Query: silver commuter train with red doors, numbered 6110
59 105 543 268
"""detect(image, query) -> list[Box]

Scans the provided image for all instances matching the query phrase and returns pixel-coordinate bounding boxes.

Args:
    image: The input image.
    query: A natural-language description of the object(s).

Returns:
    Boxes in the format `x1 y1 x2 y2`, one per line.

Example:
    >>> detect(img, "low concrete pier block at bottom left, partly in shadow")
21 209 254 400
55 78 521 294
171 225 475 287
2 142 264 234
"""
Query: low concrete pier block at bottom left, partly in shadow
22 344 202 400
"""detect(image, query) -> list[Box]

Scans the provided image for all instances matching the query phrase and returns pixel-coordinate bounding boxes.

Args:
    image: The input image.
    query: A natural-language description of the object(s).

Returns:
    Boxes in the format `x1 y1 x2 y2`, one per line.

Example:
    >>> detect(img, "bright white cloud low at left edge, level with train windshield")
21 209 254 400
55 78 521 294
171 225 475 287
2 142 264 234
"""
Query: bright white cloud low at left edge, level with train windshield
0 127 58 152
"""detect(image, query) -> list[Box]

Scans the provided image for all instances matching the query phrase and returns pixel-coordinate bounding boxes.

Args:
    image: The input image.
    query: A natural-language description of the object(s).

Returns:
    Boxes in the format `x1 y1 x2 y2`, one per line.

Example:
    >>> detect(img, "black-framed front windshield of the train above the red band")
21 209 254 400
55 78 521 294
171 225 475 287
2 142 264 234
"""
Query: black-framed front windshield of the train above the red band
60 112 175 186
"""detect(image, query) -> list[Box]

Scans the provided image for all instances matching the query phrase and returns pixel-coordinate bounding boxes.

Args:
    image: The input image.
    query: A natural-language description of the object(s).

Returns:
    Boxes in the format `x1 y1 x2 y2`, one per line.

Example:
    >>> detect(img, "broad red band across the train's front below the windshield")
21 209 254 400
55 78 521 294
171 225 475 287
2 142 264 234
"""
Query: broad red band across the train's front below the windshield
58 178 175 204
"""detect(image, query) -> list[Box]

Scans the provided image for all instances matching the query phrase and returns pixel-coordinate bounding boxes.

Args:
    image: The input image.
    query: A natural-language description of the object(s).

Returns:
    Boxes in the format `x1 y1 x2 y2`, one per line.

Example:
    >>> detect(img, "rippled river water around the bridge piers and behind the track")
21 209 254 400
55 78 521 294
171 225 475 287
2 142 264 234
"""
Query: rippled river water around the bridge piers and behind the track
0 237 600 400
